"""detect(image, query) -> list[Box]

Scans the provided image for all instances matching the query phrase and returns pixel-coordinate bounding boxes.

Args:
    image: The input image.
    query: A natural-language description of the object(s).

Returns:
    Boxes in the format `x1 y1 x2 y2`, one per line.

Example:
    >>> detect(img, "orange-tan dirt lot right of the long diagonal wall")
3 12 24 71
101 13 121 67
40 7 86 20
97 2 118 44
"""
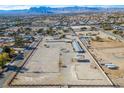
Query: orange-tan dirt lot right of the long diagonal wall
90 40 124 86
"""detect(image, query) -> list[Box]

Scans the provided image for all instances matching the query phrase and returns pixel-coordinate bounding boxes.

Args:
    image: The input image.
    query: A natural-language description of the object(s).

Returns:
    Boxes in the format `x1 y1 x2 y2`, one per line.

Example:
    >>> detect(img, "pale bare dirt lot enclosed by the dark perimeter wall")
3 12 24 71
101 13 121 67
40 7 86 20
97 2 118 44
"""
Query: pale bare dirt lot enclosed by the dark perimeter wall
11 37 111 87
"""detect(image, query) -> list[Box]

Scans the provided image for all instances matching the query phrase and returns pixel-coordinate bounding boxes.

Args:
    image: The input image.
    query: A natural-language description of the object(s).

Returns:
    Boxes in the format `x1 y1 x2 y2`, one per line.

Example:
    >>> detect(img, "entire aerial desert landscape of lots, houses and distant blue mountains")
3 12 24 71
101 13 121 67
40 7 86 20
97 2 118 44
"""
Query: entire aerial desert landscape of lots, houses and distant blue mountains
0 2 124 88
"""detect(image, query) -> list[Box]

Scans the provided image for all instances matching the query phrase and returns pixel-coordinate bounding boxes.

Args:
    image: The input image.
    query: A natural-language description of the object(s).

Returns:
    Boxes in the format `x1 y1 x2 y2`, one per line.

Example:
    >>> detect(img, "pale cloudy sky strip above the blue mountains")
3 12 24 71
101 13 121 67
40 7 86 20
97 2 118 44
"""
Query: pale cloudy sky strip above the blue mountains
0 5 124 10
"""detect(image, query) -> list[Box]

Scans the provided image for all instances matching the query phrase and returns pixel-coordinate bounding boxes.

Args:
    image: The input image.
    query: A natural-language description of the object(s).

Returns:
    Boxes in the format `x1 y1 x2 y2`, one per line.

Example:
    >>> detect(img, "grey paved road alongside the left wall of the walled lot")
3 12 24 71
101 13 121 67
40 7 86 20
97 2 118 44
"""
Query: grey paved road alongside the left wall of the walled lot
0 42 38 88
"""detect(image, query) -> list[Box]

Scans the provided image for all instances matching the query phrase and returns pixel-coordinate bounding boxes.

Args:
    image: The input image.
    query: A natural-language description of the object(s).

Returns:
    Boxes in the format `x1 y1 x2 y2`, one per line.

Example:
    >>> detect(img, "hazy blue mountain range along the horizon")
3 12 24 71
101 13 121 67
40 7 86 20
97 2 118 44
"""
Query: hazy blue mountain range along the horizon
0 6 124 14
